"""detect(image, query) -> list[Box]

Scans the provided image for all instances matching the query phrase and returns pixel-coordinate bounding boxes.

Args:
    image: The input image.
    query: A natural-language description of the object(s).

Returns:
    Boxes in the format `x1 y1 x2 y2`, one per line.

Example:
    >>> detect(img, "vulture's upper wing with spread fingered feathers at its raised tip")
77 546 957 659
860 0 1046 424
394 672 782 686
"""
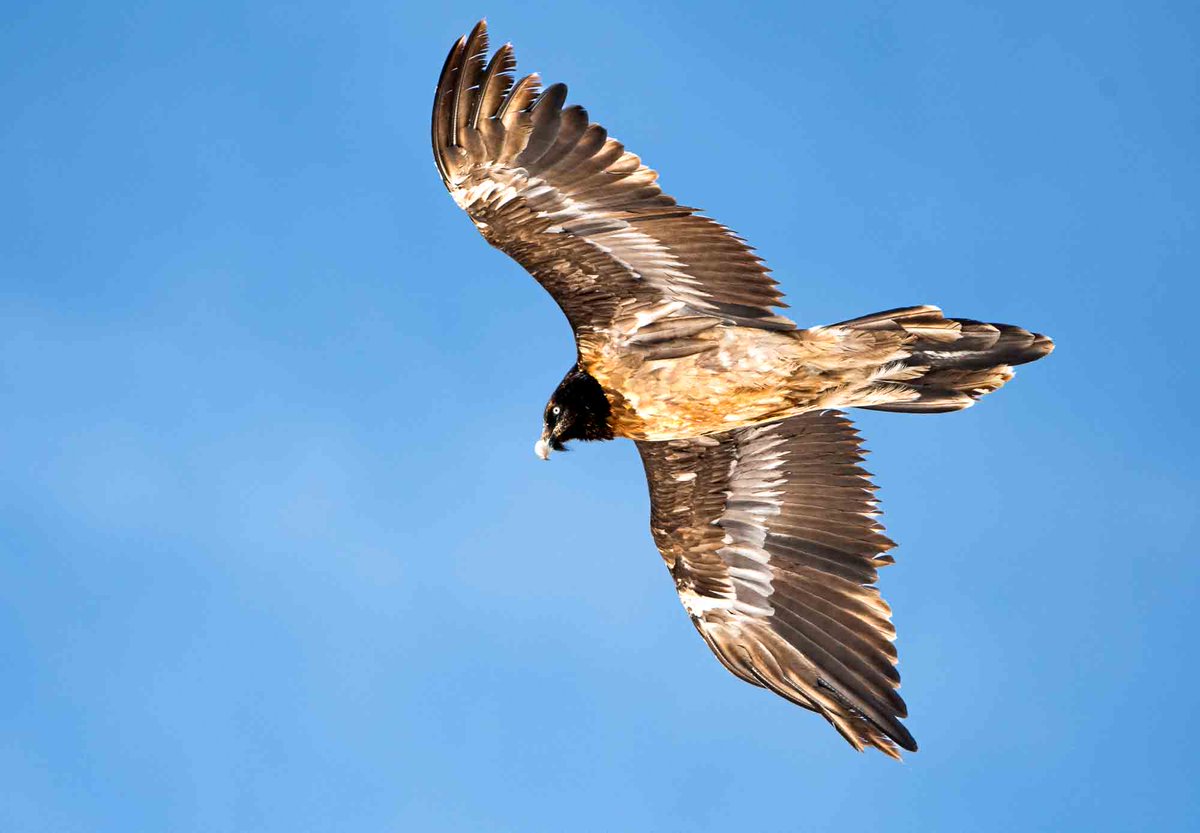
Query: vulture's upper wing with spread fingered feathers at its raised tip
432 22 794 352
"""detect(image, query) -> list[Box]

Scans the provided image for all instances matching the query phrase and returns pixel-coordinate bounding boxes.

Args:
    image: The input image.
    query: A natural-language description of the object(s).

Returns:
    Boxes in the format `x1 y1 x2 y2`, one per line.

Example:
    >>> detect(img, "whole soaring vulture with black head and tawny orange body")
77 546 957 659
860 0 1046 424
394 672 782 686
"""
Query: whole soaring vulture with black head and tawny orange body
432 22 1054 759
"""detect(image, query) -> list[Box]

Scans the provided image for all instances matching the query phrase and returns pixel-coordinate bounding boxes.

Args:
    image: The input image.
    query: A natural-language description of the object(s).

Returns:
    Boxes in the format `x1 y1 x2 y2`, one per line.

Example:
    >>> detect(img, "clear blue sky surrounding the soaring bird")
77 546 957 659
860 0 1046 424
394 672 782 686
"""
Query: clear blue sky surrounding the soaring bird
0 0 1200 833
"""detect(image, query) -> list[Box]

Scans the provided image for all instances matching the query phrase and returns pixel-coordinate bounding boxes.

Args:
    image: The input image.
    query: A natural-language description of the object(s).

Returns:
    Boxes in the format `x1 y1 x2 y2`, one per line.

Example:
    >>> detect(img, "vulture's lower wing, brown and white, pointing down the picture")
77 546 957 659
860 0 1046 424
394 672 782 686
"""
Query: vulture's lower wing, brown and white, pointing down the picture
637 410 917 757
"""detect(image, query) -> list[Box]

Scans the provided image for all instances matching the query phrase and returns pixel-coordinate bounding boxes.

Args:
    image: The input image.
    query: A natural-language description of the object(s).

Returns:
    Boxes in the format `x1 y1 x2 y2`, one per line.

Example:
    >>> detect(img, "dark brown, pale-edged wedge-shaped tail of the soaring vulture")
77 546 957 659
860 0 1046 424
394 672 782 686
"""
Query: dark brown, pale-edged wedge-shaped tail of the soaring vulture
830 306 1054 414
